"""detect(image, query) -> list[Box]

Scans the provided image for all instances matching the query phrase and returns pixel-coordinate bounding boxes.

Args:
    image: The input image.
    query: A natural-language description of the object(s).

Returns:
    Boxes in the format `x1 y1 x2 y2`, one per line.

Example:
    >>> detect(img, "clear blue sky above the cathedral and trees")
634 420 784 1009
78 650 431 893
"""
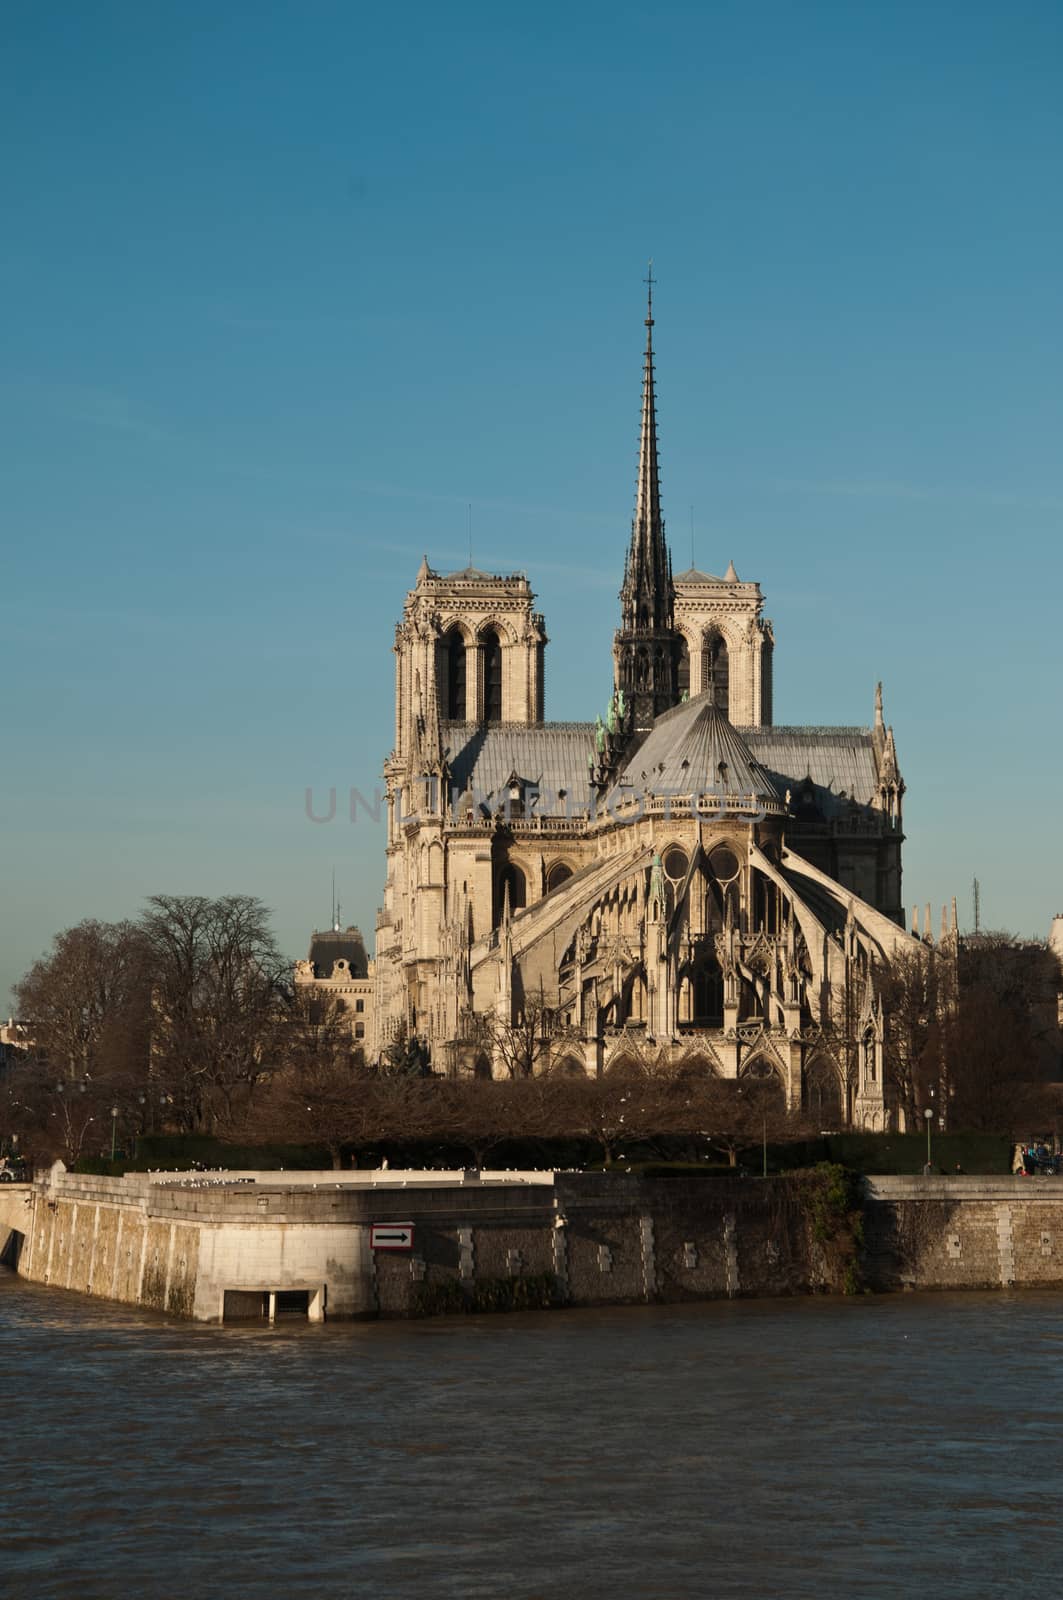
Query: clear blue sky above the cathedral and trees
0 0 1063 1005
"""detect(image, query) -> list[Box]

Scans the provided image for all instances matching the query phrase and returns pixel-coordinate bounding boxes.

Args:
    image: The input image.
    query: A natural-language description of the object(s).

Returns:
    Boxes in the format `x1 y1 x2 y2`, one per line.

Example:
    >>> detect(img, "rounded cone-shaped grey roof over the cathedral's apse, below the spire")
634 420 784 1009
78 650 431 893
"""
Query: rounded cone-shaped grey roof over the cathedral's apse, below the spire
621 694 781 810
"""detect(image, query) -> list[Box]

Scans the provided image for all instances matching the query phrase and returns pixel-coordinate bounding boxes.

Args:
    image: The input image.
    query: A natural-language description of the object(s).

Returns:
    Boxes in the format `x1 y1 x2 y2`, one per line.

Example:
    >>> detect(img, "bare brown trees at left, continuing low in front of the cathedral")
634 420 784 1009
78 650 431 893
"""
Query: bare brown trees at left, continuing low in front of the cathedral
0 896 796 1165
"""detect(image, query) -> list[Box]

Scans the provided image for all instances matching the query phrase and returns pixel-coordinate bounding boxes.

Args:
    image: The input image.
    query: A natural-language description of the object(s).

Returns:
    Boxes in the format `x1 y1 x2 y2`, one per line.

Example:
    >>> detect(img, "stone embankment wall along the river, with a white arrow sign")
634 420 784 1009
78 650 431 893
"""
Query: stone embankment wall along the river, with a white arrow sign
0 1168 1063 1322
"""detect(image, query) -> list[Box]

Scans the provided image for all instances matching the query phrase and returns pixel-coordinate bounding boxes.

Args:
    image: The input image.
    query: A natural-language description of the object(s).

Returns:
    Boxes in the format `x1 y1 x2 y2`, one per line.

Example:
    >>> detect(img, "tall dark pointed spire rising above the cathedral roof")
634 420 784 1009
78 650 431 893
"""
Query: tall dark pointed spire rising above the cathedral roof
613 264 679 733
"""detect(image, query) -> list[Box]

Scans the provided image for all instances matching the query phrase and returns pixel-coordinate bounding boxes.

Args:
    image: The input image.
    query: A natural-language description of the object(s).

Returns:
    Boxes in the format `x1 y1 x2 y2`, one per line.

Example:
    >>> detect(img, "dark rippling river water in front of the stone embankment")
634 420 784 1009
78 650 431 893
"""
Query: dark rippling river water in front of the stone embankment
0 1272 1063 1600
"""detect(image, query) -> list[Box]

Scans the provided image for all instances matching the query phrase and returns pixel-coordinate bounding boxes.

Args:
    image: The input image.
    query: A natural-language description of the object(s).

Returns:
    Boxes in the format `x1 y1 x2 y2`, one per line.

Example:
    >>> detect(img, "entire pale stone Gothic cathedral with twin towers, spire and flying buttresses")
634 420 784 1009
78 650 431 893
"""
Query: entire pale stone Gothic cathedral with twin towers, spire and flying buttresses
375 285 921 1128
